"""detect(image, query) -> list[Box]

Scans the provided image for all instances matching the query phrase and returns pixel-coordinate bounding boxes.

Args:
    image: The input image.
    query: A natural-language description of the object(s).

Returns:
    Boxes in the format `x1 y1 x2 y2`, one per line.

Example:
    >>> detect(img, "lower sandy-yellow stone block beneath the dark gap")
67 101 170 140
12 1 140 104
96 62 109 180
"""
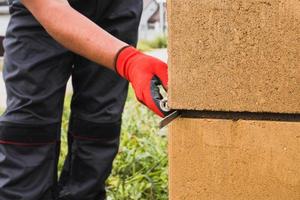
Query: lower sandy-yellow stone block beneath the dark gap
169 119 300 200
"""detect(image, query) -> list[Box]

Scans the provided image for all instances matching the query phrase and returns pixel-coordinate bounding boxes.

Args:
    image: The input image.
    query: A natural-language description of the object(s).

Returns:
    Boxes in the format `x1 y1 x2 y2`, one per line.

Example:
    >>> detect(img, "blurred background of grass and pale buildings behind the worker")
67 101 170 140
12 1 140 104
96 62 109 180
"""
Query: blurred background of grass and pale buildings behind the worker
0 0 168 200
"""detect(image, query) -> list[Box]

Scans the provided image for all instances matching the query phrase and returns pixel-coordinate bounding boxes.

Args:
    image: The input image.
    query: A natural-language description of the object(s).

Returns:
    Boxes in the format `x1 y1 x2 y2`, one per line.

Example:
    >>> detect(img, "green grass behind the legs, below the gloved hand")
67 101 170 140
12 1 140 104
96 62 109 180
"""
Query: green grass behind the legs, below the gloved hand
59 90 168 200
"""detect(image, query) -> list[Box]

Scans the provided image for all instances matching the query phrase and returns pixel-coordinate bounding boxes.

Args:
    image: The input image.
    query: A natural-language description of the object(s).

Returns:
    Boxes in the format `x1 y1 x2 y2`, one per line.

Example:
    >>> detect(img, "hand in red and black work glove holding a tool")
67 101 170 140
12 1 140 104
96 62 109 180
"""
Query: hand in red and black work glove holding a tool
115 46 168 117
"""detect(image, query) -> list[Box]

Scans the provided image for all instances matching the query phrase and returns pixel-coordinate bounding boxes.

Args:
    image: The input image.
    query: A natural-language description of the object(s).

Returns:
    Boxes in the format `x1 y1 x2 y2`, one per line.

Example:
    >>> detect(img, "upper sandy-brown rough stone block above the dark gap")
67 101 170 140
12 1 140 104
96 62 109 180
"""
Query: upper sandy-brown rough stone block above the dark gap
168 0 300 113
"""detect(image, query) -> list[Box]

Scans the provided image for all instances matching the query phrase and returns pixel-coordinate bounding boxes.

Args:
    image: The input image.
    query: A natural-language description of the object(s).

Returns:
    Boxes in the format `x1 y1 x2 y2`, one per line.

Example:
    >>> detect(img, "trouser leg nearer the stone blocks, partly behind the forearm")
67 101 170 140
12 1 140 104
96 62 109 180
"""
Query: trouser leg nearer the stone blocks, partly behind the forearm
60 0 142 200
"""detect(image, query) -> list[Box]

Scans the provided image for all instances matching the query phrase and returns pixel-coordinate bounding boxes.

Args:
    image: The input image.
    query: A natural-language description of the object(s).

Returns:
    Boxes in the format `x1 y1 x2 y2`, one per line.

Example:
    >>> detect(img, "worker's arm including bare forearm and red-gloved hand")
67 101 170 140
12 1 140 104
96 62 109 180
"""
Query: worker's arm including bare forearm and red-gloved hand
21 0 167 116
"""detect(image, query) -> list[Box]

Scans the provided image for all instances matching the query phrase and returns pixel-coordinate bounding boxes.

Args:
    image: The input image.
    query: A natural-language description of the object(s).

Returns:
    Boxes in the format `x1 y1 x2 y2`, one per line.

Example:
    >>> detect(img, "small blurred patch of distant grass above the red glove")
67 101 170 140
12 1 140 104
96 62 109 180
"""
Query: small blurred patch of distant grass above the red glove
137 36 168 51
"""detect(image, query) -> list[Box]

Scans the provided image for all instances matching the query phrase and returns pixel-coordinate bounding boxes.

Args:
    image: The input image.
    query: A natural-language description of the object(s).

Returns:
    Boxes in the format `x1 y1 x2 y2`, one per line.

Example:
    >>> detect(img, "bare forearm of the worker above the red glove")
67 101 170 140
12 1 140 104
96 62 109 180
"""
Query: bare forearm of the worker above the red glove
22 0 127 69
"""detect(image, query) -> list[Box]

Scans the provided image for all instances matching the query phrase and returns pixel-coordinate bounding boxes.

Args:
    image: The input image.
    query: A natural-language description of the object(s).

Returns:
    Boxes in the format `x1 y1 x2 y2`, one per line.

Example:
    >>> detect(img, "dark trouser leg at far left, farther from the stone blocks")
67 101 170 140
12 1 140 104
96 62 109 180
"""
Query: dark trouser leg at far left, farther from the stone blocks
0 1 72 200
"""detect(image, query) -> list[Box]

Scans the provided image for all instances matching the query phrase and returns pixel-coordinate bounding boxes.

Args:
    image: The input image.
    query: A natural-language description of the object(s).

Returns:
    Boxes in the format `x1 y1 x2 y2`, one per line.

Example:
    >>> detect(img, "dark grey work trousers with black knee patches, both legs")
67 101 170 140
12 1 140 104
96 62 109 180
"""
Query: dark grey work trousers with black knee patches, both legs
0 0 142 200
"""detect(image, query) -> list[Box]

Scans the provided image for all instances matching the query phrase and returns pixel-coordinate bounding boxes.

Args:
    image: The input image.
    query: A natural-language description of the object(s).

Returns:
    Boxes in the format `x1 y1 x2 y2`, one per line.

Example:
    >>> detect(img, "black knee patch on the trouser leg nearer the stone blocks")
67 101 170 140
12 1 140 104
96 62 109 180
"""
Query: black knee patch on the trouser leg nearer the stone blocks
69 118 121 143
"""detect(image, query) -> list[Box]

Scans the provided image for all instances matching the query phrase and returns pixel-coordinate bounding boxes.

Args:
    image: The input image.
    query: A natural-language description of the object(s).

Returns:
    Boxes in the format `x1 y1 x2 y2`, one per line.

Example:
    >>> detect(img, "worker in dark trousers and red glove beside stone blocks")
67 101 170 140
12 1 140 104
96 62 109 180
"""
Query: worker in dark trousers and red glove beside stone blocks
0 0 168 200
